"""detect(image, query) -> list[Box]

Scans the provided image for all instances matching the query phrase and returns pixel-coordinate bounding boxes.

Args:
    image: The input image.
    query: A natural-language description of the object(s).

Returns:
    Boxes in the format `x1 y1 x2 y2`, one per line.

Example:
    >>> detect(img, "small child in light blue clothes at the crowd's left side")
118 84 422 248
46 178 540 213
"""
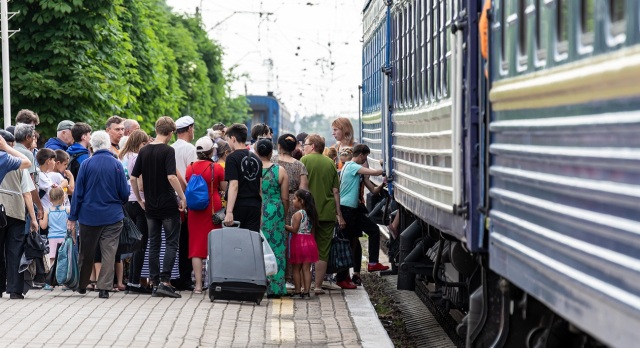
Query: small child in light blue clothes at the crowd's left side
40 186 69 290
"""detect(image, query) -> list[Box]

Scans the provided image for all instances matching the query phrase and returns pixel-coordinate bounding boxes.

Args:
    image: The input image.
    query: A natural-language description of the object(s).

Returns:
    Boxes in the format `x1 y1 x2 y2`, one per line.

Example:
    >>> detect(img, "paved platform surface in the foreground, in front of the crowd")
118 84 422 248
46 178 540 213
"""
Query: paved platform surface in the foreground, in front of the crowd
0 287 393 348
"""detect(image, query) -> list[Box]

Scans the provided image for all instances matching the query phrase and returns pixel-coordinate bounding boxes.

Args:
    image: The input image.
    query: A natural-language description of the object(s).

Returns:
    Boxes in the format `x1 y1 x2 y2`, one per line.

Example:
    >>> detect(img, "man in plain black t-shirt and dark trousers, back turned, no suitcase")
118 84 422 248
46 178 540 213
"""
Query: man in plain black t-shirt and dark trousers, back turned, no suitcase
130 116 186 298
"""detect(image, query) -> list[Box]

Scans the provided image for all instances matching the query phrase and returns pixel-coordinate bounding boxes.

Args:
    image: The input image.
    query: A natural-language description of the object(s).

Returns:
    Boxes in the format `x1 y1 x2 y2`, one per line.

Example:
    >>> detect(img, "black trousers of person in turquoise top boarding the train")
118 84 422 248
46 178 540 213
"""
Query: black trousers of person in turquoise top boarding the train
336 205 380 281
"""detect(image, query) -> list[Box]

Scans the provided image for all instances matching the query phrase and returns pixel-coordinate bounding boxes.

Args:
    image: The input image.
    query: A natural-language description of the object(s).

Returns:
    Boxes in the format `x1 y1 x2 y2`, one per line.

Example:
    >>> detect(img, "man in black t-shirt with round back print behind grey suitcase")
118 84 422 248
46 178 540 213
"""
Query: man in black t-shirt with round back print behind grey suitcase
224 123 262 232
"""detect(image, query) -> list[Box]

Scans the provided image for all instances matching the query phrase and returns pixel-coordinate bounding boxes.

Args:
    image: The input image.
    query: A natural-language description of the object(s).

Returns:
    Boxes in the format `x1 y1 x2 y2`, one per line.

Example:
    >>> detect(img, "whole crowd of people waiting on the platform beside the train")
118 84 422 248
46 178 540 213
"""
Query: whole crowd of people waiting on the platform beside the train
0 110 388 299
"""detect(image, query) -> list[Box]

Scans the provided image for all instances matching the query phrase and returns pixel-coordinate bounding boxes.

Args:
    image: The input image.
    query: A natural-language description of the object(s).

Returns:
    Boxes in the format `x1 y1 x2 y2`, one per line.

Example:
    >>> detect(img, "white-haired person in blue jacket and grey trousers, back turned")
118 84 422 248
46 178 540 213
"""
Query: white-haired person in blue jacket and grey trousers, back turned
67 131 129 298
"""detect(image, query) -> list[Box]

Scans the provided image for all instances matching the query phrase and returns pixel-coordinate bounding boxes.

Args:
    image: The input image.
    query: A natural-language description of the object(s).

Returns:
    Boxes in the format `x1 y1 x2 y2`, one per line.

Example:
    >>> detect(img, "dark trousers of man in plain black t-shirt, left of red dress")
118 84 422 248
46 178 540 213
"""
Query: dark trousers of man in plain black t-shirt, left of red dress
147 212 180 285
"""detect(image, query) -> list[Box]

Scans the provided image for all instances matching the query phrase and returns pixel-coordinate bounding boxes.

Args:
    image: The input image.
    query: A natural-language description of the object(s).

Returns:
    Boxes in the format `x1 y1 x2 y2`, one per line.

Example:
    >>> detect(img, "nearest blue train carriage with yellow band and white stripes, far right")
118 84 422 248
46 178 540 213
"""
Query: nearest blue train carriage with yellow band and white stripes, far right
489 0 640 347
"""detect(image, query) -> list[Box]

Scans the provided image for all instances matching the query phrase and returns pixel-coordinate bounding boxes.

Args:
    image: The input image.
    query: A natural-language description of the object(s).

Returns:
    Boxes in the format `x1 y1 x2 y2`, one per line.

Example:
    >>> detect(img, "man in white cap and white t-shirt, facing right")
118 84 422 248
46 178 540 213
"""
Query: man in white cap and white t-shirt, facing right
171 116 198 290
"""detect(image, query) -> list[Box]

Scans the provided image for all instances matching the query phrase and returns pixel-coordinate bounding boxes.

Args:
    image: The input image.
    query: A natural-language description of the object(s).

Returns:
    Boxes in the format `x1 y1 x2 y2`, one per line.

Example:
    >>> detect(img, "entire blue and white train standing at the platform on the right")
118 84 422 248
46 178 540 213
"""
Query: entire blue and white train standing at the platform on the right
361 0 640 347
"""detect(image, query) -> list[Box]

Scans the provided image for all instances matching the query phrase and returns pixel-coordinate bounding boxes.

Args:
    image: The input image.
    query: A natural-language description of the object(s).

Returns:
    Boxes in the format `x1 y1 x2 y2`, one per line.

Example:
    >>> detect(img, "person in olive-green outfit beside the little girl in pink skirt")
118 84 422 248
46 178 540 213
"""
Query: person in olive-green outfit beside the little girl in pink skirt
300 134 346 295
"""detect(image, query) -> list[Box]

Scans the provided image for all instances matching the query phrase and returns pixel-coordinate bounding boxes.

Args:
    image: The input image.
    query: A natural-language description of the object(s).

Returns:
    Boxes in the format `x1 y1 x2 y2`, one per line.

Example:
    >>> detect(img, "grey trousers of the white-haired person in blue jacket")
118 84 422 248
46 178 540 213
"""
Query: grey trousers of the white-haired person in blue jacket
78 220 122 290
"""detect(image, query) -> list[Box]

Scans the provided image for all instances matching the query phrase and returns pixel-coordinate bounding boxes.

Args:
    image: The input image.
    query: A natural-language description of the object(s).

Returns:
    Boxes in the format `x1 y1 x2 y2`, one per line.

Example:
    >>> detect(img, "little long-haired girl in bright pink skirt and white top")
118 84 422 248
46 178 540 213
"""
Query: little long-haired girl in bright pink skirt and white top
285 189 318 298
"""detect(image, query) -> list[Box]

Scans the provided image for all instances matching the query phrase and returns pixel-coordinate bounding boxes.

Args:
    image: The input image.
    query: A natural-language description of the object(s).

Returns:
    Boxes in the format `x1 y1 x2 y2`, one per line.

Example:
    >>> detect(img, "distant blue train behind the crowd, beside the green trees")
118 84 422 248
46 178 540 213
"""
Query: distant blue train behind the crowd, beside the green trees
247 92 294 139
